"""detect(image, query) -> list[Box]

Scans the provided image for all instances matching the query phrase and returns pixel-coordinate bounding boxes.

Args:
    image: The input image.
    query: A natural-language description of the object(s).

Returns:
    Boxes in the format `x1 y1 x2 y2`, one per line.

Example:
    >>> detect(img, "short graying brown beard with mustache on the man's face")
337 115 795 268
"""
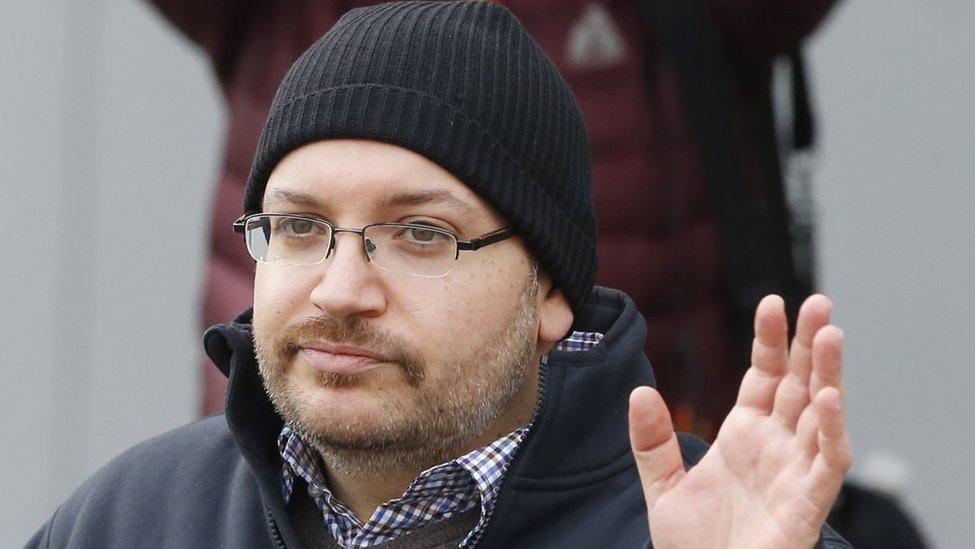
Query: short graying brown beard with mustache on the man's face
254 269 539 478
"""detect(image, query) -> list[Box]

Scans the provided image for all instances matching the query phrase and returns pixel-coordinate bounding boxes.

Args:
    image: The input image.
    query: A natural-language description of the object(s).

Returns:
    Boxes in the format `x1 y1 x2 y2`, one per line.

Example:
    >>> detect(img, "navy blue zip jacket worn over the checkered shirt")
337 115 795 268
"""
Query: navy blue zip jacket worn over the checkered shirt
22 288 848 549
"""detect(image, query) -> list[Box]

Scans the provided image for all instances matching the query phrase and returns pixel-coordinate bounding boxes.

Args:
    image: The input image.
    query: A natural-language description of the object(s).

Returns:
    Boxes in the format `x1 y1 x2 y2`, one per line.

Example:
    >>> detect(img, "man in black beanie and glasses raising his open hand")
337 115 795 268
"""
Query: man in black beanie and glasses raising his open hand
31 2 850 548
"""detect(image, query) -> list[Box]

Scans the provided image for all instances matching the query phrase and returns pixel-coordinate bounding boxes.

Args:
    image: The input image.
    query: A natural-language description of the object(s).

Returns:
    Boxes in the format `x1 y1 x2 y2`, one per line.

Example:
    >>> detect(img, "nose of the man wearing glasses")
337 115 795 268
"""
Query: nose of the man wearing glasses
310 232 386 318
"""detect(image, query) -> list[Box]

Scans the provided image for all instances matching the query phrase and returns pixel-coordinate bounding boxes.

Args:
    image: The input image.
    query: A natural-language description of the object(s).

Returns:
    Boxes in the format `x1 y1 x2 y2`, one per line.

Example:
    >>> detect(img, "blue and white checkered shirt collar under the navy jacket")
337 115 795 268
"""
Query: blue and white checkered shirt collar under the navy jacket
278 332 603 549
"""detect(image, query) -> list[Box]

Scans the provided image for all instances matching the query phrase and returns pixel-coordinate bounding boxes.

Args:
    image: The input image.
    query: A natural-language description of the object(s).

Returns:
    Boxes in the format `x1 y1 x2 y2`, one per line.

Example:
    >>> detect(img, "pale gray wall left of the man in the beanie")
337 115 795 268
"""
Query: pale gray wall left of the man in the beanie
0 0 223 547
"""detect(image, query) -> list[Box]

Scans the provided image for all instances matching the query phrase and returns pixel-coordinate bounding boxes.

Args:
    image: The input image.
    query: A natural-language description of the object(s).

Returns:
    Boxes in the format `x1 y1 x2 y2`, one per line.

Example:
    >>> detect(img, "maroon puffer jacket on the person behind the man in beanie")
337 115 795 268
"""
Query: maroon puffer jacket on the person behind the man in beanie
154 0 833 437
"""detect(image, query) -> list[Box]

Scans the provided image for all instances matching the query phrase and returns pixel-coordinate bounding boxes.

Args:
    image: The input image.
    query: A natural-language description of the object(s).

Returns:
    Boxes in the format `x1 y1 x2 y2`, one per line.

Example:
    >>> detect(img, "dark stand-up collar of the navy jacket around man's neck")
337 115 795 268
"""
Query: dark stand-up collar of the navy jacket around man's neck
204 287 654 546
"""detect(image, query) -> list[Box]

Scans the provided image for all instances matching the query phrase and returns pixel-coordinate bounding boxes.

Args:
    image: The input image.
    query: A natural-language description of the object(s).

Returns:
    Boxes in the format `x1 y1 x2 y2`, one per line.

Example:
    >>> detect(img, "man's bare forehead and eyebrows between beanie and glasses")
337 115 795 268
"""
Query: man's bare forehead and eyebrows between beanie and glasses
263 139 499 217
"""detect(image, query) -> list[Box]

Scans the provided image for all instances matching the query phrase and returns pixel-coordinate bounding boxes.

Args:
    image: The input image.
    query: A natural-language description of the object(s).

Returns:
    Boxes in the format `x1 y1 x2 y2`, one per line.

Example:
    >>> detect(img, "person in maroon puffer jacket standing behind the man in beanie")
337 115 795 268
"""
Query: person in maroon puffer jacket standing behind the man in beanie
152 0 834 439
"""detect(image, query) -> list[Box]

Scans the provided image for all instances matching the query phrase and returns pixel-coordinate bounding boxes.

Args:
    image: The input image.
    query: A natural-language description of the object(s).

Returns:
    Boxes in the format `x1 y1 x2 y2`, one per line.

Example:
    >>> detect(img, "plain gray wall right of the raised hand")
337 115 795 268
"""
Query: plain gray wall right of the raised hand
812 0 974 548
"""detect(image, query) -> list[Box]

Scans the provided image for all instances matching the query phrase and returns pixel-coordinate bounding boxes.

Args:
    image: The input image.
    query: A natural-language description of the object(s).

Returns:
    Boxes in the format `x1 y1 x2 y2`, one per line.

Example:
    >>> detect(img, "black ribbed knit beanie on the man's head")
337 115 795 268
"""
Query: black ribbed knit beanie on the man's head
244 1 597 313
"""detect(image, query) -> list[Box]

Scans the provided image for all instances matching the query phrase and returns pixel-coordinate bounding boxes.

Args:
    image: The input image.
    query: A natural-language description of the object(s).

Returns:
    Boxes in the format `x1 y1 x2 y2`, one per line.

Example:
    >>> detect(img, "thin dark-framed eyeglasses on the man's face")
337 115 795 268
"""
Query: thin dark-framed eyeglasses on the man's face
234 213 515 278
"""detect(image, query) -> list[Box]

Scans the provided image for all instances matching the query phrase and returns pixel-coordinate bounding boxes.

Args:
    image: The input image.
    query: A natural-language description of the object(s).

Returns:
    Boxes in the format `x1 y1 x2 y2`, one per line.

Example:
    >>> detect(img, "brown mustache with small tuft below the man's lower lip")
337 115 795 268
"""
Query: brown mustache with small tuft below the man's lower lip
274 315 425 386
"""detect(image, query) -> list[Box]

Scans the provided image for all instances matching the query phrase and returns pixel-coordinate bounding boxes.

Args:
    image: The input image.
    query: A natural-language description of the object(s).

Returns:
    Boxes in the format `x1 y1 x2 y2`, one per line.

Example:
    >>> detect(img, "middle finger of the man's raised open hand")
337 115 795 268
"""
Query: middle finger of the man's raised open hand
773 295 832 429
